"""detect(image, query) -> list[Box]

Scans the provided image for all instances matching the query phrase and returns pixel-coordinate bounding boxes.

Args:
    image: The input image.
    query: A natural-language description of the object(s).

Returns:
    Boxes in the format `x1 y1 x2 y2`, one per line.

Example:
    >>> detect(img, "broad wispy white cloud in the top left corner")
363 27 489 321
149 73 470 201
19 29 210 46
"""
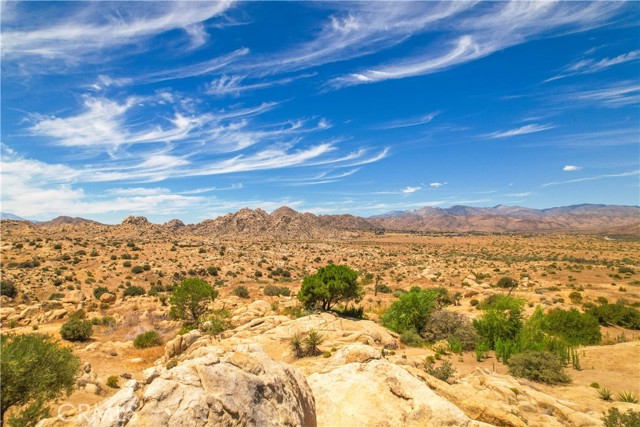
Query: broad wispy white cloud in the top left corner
2 0 233 65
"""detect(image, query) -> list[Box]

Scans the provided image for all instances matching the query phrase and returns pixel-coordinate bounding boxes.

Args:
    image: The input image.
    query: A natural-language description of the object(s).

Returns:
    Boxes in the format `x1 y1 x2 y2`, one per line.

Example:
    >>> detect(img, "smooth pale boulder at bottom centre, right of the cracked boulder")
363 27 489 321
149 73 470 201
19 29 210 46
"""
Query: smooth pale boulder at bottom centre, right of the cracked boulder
307 346 488 427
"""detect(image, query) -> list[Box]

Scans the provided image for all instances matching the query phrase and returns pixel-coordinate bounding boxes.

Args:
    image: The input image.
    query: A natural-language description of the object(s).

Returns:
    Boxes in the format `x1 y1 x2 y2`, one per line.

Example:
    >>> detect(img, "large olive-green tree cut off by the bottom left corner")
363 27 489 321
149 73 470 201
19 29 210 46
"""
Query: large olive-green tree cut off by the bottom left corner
0 334 80 426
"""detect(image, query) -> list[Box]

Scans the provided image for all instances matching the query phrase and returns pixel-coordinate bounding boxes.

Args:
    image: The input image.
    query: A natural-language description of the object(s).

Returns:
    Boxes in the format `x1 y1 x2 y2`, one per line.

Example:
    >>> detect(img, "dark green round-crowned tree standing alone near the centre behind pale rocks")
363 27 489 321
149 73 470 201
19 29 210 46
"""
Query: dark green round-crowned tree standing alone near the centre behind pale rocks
298 265 363 310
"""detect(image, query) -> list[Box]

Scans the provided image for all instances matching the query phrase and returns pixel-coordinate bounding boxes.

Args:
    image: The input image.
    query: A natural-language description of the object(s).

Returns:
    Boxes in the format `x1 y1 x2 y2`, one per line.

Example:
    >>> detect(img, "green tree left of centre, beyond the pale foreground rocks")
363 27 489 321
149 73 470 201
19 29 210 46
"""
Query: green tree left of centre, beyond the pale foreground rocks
169 278 218 324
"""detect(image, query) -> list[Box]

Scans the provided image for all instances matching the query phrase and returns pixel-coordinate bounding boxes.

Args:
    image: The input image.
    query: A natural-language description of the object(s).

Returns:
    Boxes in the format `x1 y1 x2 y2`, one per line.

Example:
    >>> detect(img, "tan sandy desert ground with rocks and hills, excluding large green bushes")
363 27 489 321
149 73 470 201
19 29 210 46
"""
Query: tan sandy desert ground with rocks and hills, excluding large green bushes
0 208 640 426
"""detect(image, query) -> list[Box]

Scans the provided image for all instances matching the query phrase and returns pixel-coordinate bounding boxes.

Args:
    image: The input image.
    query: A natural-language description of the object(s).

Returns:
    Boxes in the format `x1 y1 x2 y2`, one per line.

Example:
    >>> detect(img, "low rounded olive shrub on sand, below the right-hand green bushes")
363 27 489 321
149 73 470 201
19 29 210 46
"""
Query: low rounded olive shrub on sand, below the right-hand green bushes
509 350 571 384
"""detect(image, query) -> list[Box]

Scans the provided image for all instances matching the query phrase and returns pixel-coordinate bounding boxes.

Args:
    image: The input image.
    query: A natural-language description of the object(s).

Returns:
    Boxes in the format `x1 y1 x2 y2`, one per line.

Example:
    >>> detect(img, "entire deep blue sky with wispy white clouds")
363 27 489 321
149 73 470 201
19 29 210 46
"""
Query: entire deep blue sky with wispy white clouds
1 1 640 223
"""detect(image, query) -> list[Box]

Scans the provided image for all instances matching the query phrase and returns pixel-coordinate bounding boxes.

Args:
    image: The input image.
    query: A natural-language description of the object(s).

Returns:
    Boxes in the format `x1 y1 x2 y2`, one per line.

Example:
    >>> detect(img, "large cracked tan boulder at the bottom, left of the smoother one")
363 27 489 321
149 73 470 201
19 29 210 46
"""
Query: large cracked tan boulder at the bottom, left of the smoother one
39 345 316 427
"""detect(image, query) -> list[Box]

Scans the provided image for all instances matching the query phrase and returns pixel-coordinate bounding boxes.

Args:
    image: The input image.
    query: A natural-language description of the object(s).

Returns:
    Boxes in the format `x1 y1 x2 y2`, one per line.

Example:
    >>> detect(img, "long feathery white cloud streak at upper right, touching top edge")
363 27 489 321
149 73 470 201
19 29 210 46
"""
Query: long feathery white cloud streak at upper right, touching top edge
329 1 622 88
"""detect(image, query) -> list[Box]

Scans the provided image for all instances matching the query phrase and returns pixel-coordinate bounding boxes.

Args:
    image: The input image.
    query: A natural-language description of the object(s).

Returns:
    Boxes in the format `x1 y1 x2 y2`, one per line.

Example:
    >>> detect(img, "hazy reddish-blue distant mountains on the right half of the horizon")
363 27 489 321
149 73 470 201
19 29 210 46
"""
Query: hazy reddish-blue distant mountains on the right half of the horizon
368 205 640 235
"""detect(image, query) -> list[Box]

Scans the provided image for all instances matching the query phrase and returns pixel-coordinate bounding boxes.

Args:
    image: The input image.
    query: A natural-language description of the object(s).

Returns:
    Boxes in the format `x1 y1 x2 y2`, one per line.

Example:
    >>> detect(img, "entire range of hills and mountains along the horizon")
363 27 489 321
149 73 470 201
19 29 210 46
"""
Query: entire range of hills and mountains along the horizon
2 204 640 239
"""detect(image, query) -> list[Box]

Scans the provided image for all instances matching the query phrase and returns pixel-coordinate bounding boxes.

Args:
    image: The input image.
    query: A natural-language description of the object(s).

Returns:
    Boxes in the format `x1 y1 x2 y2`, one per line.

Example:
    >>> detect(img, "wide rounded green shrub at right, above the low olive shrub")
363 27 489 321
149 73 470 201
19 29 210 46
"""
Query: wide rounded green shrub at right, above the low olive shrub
542 309 602 346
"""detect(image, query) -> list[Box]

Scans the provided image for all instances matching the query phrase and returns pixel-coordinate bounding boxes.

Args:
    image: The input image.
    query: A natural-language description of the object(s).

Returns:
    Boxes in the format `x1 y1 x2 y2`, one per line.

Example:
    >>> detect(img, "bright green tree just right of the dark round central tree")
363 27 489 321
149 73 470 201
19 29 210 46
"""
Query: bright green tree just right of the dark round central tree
381 286 439 334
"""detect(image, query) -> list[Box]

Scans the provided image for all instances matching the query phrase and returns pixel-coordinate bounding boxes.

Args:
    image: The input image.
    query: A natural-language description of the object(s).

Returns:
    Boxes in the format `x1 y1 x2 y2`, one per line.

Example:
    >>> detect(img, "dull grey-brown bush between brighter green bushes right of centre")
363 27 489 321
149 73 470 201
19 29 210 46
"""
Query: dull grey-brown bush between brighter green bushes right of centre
420 310 477 350
